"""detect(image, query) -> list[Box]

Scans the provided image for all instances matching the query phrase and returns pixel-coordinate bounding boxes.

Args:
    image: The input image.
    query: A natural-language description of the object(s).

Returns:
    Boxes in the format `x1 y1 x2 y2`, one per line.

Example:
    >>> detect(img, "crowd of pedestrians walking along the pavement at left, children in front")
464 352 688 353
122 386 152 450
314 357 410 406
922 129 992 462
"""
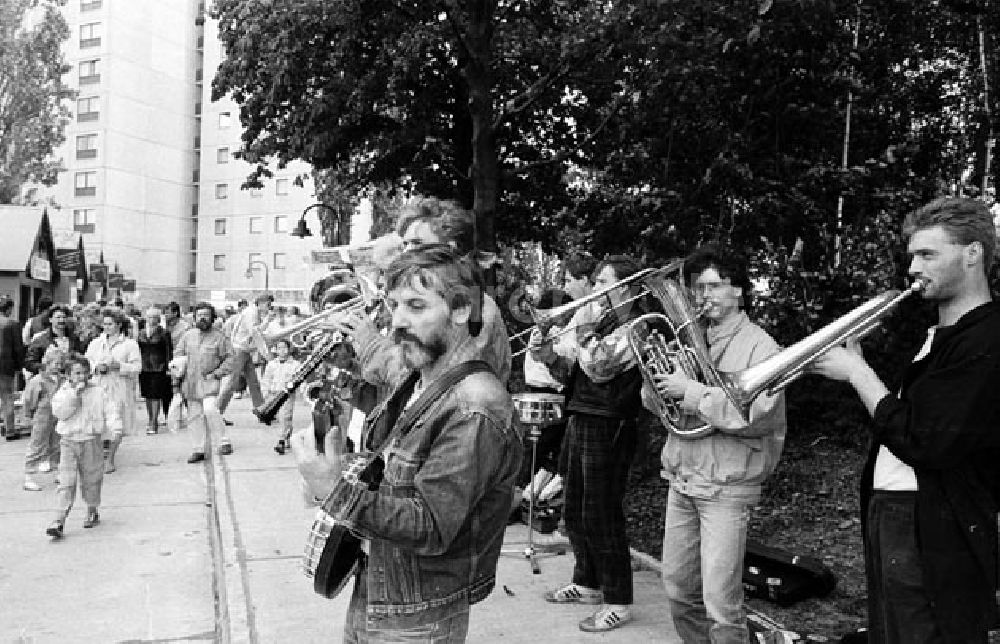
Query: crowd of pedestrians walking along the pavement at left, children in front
0 295 302 537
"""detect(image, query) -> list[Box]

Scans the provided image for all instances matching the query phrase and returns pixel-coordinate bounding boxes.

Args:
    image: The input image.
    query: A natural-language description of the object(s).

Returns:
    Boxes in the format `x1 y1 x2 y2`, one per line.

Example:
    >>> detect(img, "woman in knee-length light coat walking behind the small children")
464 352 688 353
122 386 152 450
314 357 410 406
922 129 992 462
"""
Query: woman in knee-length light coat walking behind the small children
87 308 142 474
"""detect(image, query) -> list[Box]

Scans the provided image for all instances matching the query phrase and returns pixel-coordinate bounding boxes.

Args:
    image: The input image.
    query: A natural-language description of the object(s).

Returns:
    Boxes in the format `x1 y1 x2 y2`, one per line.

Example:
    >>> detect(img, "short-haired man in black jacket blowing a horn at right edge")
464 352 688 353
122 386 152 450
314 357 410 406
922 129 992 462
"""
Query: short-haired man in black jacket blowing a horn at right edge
816 197 1000 644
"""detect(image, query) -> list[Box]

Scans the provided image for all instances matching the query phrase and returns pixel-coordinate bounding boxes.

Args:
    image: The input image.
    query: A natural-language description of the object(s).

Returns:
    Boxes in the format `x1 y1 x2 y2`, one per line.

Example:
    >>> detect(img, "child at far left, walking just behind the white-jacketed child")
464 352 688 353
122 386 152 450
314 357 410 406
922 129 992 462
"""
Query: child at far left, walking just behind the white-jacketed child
24 351 66 492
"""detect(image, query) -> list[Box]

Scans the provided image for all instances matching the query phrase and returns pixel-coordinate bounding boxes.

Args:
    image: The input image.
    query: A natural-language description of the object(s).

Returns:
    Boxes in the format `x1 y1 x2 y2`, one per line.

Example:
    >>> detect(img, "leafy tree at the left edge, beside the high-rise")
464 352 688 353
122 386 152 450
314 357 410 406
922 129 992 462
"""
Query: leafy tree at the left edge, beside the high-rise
0 0 73 203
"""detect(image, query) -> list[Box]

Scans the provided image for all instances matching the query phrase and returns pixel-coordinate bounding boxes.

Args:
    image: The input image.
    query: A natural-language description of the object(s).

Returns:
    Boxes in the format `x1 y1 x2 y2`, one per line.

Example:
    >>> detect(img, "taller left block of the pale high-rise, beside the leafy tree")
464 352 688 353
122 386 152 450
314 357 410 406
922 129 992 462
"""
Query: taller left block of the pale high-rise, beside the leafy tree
32 0 202 302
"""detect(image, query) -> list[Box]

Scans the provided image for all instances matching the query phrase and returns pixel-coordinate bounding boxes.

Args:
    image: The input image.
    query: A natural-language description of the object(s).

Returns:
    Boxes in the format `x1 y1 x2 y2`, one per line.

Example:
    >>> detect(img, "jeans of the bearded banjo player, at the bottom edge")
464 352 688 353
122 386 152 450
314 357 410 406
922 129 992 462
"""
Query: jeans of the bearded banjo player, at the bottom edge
343 568 469 644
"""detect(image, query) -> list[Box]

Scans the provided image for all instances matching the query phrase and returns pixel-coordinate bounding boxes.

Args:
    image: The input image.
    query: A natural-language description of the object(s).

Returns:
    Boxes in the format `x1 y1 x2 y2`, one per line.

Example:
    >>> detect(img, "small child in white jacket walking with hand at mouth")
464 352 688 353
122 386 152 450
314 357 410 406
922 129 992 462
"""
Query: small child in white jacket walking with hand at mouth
45 355 122 538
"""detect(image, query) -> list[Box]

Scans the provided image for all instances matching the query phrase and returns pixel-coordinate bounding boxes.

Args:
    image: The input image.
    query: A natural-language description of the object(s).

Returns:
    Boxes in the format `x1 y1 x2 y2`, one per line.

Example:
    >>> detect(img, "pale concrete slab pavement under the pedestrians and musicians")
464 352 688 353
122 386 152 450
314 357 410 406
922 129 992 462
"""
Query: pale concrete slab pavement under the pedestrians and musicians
0 399 665 643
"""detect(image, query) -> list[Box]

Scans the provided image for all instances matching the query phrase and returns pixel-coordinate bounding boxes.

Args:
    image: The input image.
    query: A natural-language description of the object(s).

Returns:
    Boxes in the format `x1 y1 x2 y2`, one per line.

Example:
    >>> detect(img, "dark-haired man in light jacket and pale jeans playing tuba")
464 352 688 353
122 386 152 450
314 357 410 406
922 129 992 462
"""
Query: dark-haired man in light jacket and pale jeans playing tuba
643 247 785 644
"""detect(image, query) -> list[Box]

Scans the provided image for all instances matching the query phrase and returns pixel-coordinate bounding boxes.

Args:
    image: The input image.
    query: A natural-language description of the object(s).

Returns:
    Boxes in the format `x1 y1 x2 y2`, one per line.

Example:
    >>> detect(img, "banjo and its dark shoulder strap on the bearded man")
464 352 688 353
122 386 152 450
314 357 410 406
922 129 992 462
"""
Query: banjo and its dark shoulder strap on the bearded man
302 360 493 599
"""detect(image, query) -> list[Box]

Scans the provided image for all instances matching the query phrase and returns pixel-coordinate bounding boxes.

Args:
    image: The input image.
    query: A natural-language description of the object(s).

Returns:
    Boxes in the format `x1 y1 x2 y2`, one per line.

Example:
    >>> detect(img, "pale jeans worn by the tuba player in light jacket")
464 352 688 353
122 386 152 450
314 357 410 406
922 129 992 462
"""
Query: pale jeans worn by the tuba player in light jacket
663 488 753 644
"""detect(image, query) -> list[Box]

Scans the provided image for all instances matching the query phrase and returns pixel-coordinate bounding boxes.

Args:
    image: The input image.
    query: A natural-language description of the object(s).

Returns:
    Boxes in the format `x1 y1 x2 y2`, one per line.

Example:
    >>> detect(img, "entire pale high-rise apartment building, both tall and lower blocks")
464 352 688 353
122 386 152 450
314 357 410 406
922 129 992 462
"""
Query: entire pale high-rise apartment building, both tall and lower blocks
27 0 371 304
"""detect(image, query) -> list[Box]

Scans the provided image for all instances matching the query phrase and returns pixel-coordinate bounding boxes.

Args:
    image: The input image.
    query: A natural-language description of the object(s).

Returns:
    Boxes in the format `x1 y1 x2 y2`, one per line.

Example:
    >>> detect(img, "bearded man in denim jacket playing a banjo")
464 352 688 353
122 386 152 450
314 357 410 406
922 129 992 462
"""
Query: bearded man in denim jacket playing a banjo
291 246 522 642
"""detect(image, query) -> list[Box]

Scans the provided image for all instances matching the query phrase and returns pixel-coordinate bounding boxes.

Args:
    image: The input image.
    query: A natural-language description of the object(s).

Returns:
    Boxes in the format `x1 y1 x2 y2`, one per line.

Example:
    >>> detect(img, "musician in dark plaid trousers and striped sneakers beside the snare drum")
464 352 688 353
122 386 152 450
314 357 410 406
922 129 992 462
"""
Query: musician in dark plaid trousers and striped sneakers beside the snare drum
529 256 642 632
